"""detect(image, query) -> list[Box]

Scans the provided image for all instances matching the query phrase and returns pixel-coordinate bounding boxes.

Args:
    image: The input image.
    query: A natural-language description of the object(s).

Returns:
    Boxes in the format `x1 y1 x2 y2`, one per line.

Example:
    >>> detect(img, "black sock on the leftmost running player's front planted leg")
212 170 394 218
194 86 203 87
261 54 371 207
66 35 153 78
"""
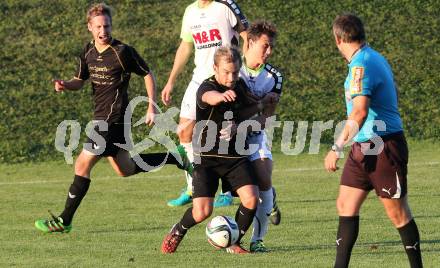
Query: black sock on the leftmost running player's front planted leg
60 175 90 225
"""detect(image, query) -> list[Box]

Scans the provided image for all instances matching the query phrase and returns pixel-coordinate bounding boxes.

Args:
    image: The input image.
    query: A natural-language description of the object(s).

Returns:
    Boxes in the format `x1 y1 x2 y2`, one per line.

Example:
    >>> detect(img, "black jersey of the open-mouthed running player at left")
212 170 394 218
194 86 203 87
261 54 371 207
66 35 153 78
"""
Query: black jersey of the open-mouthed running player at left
75 39 149 123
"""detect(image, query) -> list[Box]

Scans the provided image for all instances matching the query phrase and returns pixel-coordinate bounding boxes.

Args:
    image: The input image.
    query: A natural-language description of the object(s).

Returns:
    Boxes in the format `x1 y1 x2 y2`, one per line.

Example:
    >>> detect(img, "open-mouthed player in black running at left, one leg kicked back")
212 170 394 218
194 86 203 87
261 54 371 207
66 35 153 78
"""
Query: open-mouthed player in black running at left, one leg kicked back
35 4 191 233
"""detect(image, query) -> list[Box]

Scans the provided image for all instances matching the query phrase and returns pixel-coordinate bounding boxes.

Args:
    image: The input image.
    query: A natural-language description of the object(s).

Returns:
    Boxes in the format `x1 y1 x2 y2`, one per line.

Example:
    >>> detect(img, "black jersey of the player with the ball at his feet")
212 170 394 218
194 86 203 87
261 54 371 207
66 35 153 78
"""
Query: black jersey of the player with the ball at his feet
193 77 254 157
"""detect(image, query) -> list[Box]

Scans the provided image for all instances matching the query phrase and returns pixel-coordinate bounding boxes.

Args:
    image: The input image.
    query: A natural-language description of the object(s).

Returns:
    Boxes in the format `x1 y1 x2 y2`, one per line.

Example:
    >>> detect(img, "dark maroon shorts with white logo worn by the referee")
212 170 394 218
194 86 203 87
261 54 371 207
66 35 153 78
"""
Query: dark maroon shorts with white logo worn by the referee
341 132 408 199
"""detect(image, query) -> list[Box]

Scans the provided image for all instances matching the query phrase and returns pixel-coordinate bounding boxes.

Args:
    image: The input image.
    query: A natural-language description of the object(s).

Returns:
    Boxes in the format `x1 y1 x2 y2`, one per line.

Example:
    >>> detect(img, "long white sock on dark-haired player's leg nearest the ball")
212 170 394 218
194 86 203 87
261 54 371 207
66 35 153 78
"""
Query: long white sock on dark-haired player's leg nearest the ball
251 188 273 242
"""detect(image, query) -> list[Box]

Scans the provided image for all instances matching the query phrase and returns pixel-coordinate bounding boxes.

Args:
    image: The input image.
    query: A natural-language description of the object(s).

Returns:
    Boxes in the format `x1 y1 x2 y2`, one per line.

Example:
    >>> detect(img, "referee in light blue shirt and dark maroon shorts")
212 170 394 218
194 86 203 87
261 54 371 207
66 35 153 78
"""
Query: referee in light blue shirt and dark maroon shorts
324 14 423 268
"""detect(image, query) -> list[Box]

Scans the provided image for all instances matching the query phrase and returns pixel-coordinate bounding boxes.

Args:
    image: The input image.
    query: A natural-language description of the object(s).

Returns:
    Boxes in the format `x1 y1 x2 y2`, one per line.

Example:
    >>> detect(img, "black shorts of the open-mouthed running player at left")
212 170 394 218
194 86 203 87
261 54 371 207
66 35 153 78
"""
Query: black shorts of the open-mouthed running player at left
84 122 126 157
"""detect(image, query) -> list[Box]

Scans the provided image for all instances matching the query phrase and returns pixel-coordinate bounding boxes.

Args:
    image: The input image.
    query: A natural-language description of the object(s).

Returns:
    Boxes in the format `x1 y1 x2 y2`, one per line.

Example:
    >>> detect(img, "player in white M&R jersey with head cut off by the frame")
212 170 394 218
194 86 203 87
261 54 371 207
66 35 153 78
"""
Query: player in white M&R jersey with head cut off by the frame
161 0 248 206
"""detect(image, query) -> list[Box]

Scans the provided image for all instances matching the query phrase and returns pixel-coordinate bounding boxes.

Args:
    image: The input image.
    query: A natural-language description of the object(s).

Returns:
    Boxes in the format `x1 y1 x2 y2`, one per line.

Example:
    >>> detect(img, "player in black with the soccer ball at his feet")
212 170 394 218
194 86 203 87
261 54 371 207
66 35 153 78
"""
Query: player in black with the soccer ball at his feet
162 47 276 254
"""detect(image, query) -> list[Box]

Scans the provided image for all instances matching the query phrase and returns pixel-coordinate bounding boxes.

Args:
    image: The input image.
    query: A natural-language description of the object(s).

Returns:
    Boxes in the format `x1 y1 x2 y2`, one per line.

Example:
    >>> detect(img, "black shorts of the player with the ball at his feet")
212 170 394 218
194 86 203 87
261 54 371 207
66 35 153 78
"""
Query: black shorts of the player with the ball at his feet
193 156 256 198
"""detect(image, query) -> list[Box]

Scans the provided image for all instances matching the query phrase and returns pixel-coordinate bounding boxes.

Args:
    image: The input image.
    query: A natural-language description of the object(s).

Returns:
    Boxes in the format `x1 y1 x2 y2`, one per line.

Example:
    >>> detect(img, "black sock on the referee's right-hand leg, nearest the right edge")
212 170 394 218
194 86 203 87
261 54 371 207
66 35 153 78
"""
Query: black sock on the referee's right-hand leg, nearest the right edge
397 219 423 268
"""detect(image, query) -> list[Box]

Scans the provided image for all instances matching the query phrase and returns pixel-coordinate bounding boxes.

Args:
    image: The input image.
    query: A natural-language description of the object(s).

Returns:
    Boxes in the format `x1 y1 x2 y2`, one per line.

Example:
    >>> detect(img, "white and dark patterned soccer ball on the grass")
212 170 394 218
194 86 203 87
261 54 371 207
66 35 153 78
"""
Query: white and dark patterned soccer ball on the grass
206 216 239 248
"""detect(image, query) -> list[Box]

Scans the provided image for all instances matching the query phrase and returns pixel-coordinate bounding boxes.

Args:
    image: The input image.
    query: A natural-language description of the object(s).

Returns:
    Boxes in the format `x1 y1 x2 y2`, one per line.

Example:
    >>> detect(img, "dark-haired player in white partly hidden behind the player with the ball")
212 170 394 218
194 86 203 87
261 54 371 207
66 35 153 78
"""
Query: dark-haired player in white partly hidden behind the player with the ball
240 21 283 252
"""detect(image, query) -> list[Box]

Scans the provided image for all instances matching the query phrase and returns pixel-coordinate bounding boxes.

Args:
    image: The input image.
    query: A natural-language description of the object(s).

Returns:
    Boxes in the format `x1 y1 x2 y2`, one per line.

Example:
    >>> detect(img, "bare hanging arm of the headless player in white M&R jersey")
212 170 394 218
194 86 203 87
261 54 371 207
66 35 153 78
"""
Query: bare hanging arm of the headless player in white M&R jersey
161 41 193 105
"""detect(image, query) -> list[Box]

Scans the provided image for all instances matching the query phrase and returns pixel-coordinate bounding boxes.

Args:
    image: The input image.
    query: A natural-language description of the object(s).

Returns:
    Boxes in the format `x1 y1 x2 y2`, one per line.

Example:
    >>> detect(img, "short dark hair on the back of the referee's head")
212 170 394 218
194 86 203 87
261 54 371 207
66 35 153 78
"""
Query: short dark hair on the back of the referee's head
333 13 365 43
